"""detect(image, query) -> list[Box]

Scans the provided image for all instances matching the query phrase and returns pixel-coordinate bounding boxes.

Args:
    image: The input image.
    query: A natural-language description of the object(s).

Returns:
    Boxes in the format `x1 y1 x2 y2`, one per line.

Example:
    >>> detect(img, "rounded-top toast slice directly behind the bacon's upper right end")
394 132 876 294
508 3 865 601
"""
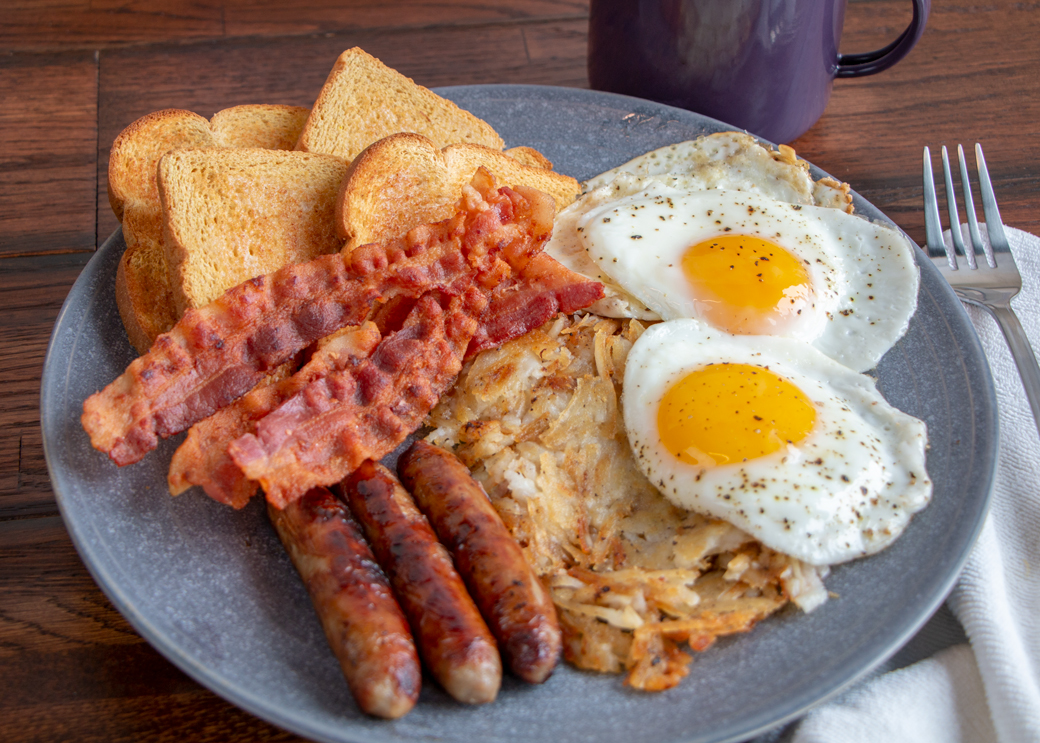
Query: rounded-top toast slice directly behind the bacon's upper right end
336 133 581 251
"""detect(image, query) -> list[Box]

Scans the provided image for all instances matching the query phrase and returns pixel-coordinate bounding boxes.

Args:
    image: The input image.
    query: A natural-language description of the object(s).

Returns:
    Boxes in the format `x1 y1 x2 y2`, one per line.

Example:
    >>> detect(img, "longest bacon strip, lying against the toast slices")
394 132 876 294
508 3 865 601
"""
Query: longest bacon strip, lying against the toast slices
81 172 552 466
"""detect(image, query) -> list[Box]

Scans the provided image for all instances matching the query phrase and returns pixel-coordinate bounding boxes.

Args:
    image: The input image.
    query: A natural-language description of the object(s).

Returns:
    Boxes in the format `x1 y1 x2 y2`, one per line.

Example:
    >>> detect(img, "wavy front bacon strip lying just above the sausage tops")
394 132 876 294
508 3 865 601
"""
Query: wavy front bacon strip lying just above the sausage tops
228 287 488 508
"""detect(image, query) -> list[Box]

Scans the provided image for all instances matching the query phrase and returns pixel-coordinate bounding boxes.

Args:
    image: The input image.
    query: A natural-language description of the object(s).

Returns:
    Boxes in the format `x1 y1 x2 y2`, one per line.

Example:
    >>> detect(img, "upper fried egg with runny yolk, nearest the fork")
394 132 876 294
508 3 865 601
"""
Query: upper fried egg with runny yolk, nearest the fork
576 182 918 372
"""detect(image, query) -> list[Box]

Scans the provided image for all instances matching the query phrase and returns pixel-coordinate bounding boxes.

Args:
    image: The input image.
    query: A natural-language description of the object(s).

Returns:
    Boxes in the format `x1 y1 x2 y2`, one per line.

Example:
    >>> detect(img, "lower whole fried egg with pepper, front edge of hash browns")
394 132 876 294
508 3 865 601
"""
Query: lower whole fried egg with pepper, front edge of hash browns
622 319 932 565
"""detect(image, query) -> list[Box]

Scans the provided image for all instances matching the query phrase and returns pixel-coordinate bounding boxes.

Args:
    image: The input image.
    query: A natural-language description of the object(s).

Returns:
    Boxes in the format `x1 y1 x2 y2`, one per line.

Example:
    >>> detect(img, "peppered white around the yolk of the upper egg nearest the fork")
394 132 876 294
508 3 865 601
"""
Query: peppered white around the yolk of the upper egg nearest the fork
575 182 918 372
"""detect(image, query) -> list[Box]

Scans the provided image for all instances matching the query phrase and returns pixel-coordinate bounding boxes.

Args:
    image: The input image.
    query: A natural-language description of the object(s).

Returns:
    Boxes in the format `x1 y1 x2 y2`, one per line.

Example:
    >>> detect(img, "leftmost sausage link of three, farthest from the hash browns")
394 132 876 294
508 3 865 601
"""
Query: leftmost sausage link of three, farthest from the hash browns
267 488 422 718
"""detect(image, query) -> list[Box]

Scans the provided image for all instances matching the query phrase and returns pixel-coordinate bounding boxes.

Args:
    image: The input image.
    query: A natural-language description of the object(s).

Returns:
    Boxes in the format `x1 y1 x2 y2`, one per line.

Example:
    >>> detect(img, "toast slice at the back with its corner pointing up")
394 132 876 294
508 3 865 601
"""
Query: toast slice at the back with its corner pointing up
296 47 504 162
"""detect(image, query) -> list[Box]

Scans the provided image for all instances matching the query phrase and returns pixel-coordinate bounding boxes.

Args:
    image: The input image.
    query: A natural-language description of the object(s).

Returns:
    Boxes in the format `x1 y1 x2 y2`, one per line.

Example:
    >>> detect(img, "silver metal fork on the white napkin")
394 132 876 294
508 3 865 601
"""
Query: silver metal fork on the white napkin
925 145 1040 434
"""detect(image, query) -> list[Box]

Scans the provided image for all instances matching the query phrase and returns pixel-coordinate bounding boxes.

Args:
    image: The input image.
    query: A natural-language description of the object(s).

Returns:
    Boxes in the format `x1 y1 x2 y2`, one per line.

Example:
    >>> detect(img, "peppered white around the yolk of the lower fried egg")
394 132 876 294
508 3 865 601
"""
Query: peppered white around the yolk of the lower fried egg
622 319 932 565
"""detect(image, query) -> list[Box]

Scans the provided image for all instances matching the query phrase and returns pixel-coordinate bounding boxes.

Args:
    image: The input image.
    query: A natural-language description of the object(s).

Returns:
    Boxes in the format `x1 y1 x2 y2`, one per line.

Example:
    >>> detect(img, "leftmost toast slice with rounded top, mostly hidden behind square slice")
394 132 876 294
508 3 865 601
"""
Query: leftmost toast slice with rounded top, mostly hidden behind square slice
108 105 310 353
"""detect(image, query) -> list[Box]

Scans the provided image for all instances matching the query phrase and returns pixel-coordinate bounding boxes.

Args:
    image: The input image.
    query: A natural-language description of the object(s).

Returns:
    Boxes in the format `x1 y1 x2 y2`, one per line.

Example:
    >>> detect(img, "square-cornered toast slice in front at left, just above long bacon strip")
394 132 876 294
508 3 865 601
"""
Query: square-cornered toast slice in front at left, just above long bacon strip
158 148 346 314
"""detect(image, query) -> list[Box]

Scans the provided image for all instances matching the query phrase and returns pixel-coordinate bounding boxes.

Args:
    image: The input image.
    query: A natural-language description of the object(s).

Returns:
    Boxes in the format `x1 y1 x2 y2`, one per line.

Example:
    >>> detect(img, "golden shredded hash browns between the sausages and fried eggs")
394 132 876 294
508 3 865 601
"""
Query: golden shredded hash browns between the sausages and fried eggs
427 314 826 691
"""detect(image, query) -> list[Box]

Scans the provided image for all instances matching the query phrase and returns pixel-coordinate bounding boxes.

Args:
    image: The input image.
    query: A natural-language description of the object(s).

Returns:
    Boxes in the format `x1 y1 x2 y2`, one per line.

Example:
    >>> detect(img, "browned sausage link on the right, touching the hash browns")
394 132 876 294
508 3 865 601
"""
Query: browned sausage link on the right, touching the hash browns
397 440 563 684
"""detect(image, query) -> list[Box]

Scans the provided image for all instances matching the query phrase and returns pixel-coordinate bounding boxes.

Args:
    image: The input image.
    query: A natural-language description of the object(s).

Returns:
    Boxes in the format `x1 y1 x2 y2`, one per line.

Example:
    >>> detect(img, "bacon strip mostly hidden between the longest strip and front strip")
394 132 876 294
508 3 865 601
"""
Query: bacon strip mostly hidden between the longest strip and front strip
167 323 382 508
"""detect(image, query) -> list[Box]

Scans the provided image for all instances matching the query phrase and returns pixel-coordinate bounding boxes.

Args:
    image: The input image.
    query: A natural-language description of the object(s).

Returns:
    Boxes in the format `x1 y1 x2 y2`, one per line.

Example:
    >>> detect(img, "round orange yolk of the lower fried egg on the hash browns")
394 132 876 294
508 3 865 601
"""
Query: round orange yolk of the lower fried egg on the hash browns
657 363 816 467
